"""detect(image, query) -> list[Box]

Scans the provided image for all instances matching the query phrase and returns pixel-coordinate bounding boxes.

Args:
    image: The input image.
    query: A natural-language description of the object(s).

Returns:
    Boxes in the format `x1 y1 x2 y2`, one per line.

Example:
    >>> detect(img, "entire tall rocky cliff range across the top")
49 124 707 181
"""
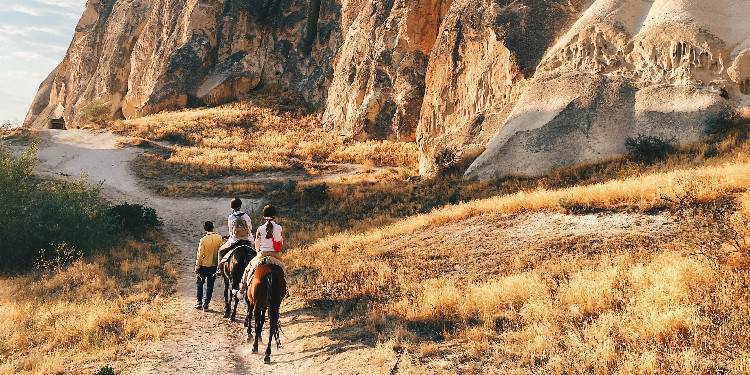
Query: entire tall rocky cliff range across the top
24 0 750 178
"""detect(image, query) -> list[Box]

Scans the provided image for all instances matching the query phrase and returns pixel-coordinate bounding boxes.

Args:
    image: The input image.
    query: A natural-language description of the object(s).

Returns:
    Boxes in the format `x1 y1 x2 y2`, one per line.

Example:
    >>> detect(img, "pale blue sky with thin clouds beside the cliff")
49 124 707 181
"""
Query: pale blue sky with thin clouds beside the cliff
0 0 86 125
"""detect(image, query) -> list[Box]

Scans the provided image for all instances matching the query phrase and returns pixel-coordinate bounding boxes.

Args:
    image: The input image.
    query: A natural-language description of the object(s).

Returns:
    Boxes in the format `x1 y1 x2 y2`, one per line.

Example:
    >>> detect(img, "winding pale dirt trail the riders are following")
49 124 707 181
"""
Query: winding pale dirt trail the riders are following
37 130 396 374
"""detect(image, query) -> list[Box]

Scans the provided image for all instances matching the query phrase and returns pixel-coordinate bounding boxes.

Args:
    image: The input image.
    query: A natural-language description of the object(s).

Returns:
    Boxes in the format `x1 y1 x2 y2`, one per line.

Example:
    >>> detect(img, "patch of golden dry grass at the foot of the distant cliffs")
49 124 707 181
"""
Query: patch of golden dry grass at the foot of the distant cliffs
108 95 418 178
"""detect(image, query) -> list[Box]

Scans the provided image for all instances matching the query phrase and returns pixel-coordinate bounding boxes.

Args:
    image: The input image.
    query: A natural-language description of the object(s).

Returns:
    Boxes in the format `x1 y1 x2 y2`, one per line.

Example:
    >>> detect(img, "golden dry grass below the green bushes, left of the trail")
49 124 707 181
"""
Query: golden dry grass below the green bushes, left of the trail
0 237 176 374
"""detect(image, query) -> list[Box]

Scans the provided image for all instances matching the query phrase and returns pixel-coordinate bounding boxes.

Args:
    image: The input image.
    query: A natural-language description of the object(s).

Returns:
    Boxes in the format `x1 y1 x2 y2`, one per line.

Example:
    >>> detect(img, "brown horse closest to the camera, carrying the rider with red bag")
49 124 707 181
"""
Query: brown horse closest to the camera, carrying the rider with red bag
247 261 286 363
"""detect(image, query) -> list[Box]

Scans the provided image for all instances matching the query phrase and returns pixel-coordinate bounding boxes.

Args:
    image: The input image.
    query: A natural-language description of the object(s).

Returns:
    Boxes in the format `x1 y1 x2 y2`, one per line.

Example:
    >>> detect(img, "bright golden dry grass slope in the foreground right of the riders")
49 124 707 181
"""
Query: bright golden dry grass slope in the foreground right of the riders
286 110 750 374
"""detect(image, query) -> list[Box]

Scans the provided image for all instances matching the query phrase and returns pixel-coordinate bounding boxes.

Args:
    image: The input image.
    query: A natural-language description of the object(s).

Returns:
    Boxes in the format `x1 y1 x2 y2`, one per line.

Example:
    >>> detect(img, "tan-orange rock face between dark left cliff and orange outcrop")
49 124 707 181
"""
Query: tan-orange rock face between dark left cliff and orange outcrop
324 0 451 141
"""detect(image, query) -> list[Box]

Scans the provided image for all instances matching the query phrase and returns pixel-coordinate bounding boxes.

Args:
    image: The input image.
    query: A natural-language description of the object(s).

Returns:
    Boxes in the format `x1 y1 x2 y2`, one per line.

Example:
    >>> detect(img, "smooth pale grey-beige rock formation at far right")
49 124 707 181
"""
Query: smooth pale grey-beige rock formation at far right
466 0 750 178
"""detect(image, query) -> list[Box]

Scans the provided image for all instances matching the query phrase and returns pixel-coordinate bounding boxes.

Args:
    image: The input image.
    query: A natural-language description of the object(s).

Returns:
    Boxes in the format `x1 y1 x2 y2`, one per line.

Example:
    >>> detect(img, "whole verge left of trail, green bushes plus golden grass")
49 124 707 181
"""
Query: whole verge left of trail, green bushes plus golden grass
0 139 176 374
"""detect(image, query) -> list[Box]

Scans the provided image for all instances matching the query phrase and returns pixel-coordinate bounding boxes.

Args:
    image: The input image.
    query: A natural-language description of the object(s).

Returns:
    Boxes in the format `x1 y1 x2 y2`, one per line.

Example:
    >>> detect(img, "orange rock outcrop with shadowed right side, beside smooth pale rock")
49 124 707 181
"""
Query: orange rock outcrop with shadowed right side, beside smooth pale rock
417 0 588 174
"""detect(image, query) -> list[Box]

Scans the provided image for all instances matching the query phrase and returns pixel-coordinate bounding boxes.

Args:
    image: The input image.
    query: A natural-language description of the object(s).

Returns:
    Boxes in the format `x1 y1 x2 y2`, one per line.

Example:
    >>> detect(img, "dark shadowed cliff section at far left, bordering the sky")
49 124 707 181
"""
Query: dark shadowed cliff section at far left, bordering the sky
24 0 341 127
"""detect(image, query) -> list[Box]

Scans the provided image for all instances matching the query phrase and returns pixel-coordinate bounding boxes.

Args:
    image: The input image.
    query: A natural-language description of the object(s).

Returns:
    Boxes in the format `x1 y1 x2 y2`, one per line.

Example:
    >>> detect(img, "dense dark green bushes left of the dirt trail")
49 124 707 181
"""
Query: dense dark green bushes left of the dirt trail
0 143 161 272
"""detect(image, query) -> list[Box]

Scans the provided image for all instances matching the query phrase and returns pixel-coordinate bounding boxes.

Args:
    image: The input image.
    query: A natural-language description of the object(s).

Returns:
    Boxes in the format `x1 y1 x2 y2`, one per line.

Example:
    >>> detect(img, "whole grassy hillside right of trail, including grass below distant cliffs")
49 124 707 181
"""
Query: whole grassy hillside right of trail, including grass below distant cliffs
79 92 750 374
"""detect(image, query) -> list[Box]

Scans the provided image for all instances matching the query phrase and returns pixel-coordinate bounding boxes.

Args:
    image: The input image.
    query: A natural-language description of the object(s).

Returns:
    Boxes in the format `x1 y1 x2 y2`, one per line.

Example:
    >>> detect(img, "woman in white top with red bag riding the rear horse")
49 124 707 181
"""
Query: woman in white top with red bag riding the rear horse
240 205 286 294
